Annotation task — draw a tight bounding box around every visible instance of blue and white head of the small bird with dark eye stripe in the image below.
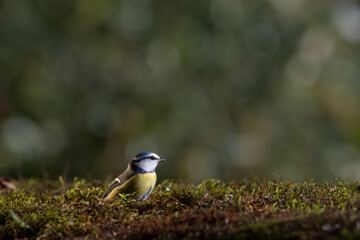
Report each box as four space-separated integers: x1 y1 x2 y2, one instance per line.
129 152 165 172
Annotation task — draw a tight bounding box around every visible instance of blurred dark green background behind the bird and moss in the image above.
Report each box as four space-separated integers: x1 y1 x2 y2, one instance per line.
0 0 360 182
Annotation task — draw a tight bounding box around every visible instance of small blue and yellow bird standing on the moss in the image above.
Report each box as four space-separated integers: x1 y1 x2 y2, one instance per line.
102 152 165 201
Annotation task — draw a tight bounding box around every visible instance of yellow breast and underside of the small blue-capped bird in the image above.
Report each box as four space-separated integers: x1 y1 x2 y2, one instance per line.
107 172 156 200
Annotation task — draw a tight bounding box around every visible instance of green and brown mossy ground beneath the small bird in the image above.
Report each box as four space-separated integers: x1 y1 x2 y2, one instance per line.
0 178 360 239
